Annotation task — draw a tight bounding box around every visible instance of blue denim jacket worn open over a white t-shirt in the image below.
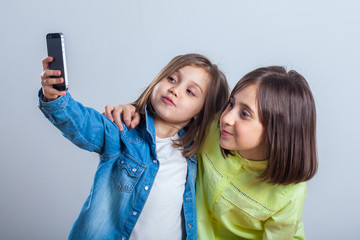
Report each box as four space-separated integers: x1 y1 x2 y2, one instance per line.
39 90 197 240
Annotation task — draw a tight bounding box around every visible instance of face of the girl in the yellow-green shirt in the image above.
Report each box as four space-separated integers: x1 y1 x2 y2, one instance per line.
220 84 266 160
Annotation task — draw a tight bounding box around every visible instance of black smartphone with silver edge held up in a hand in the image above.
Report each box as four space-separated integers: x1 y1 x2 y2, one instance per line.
46 33 69 91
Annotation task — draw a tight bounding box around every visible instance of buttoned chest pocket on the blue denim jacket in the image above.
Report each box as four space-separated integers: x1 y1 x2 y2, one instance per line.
111 155 145 192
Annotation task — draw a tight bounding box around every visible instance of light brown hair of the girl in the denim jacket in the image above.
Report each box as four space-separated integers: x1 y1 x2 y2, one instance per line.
134 53 229 157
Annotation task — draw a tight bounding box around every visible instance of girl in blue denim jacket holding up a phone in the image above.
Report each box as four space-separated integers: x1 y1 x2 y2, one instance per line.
39 54 228 240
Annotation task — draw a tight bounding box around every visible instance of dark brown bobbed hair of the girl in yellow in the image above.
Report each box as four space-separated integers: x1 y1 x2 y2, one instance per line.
222 66 318 185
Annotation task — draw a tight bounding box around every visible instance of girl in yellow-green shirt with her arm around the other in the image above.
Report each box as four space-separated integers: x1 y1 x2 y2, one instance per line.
107 66 317 240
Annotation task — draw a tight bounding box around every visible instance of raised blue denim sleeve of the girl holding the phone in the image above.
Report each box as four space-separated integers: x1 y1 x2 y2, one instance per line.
39 90 120 155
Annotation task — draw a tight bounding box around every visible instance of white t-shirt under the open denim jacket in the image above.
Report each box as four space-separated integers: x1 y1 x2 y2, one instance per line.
130 135 187 240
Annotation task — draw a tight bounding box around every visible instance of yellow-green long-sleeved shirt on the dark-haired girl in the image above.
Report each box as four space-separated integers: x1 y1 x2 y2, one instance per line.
196 119 307 240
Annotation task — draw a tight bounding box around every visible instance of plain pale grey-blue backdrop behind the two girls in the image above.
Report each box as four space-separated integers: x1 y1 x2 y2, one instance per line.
0 0 360 239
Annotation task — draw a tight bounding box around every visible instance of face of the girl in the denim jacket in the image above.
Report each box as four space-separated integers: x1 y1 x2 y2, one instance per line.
151 63 210 128
